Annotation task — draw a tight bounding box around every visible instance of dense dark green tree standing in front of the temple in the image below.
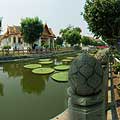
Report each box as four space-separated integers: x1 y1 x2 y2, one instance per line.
21 17 43 46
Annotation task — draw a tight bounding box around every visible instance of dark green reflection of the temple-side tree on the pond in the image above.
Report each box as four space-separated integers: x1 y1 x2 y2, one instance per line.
21 69 49 95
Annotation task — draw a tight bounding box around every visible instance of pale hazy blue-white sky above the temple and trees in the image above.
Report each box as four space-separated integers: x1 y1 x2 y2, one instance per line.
0 0 91 36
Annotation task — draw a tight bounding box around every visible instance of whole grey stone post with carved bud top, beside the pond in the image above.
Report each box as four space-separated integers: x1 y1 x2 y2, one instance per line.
68 53 105 120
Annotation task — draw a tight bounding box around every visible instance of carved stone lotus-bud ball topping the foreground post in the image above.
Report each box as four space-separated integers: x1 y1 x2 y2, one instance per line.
68 53 103 96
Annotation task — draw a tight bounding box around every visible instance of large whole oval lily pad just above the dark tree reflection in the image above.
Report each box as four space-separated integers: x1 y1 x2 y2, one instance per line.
32 68 54 74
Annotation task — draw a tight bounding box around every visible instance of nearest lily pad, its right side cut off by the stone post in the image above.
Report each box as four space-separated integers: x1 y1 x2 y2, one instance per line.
51 72 68 82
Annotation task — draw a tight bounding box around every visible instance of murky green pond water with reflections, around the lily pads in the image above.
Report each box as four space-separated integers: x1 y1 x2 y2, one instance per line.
0 55 75 120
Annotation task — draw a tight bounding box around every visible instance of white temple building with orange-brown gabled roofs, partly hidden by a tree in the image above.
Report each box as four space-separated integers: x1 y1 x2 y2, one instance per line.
0 24 55 50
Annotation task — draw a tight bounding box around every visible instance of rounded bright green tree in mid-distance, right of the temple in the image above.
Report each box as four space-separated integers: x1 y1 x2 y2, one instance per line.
60 26 81 46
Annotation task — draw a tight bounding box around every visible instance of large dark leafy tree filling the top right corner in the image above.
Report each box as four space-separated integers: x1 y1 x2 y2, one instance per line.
83 0 120 49
